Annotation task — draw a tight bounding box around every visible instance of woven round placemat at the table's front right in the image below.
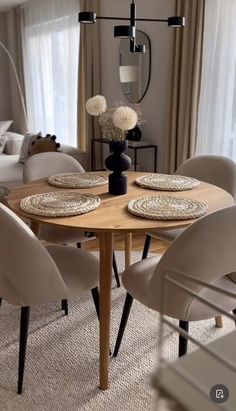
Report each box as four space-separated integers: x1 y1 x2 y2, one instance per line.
128 195 208 220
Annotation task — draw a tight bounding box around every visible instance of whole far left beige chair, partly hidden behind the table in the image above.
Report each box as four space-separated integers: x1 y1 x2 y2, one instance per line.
23 152 120 292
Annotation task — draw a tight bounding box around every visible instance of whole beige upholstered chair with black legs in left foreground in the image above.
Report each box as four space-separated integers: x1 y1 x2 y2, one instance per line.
0 204 99 394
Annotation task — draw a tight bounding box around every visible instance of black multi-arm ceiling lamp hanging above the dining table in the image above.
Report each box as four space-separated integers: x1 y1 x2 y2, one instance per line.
79 0 185 53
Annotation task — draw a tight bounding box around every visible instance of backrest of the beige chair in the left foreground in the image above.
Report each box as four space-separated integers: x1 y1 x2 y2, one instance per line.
0 204 66 306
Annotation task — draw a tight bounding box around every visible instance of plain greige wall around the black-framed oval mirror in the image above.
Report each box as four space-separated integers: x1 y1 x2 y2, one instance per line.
101 0 175 171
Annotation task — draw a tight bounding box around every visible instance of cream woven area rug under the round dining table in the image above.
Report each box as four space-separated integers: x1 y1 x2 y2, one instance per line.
0 252 234 411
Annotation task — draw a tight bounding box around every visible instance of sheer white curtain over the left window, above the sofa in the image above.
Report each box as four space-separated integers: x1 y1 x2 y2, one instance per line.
22 0 80 146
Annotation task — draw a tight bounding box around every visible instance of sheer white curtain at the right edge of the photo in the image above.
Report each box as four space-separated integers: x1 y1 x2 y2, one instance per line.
196 0 236 160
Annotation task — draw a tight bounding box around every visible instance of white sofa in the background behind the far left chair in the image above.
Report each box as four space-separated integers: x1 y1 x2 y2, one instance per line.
0 131 88 188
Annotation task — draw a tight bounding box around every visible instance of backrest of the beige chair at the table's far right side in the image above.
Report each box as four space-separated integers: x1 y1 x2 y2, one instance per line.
175 155 236 198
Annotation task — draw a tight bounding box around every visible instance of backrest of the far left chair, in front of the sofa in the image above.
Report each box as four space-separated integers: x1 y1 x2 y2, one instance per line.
23 152 84 183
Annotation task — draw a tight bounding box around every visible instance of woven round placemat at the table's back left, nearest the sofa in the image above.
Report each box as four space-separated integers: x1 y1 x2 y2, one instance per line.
48 173 108 188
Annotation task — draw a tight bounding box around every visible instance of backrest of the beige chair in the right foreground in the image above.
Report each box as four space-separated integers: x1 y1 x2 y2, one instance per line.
147 206 236 319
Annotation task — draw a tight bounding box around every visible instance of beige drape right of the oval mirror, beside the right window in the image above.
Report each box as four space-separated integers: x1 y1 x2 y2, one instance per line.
165 0 205 173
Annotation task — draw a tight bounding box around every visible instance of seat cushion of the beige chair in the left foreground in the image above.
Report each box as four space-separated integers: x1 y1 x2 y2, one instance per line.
46 245 99 298
